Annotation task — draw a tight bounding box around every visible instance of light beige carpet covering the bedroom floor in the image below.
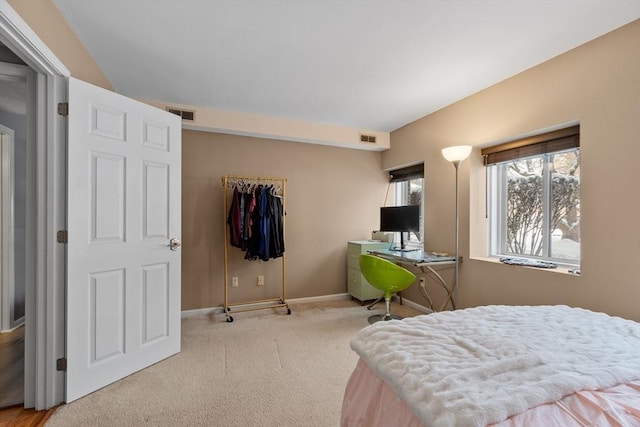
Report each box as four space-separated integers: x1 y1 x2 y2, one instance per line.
46 300 420 427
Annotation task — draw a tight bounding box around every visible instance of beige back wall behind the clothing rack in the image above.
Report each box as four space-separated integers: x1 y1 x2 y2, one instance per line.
182 131 388 310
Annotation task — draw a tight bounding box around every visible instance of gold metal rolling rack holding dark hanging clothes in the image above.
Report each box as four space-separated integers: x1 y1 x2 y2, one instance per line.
221 175 291 322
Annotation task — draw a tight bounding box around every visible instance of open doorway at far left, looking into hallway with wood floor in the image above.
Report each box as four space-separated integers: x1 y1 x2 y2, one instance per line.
0 49 33 408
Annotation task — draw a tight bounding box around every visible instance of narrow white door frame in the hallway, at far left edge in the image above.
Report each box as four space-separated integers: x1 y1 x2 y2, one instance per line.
0 124 15 331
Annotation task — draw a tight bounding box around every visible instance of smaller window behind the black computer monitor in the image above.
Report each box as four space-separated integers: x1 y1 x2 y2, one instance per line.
389 163 424 249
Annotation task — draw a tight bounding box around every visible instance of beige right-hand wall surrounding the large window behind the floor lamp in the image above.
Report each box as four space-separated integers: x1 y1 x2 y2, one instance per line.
382 21 640 320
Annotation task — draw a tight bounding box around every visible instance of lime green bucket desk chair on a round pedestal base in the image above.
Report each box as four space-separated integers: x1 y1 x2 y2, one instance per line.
358 254 416 323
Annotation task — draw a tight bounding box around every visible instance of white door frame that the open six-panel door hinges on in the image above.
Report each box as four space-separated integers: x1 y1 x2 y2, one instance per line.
0 0 71 410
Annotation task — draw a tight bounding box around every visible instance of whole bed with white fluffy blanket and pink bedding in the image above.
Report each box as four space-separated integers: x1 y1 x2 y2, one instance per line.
341 306 640 427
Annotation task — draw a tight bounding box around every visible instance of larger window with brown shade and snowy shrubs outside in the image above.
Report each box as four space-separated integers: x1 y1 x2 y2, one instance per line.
482 126 580 266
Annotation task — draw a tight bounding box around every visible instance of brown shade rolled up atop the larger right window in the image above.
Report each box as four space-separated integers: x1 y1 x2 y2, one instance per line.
481 125 580 165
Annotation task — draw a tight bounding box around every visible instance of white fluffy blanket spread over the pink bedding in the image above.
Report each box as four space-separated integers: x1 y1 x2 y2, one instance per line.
351 306 640 427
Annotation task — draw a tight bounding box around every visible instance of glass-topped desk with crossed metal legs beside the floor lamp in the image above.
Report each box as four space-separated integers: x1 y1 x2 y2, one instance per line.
369 249 456 311
